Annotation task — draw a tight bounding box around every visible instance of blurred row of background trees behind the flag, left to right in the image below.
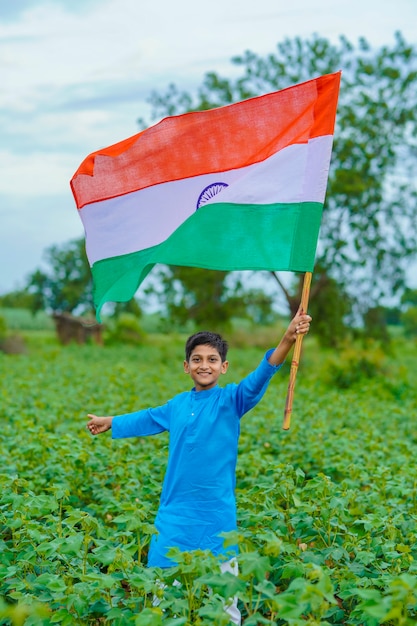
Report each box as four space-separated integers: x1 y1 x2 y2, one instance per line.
1 33 417 345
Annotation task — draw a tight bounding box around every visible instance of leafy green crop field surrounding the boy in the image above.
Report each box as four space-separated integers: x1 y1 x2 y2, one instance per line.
0 336 417 626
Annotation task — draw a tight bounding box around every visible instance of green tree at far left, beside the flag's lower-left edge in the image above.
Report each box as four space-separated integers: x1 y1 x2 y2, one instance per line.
27 239 94 313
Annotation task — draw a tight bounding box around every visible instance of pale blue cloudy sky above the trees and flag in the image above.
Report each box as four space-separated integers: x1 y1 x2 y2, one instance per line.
0 0 417 294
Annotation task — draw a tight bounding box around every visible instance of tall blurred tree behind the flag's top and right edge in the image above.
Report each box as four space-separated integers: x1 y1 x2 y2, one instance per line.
141 33 417 336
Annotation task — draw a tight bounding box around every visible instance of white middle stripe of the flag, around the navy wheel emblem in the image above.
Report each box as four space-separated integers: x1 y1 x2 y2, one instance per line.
80 135 333 265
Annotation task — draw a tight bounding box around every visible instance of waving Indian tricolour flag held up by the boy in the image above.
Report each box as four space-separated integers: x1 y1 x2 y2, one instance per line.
71 72 340 317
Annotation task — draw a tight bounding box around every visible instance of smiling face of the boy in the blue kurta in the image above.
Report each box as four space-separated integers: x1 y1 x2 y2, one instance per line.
184 345 229 391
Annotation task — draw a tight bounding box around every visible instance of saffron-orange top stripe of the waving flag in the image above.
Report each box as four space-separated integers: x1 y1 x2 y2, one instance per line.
71 72 340 208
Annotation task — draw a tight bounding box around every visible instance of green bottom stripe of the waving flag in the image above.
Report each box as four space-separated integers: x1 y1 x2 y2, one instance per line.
92 202 323 315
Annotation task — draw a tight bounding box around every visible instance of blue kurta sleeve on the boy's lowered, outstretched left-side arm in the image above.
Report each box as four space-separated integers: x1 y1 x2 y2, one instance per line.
112 402 170 439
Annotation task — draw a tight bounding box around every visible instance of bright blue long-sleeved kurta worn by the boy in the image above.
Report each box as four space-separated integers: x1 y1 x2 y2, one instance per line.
112 350 281 567
